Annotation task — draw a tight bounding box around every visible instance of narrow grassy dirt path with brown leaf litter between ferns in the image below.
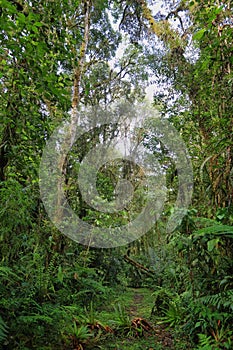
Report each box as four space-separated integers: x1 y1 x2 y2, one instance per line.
101 288 191 350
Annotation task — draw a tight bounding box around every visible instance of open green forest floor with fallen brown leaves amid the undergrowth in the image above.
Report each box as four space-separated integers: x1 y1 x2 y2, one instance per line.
96 288 189 350
